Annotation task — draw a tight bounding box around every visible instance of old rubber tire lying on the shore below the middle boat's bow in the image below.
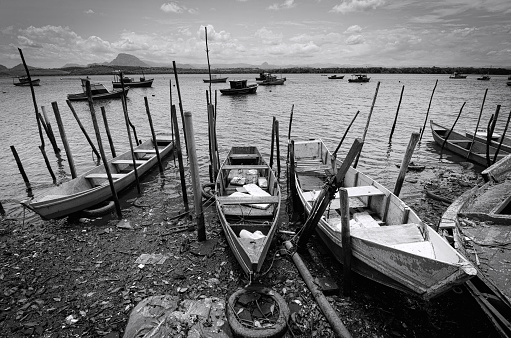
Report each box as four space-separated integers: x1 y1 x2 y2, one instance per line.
226 286 289 338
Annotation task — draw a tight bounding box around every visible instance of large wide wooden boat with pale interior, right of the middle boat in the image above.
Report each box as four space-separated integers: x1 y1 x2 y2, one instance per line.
290 140 476 299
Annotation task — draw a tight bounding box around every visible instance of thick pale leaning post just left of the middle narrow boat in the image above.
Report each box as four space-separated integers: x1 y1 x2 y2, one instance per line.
184 111 206 242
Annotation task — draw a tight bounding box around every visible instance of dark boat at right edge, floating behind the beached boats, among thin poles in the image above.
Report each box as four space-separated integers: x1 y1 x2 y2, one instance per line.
430 120 509 167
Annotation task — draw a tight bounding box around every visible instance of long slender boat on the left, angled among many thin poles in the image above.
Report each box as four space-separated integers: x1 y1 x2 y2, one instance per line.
21 135 174 219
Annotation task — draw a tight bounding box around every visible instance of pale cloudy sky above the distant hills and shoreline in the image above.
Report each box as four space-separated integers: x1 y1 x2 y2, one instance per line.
0 0 511 68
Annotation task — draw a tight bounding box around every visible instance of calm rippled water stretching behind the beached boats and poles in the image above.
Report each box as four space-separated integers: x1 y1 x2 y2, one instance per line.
0 74 511 217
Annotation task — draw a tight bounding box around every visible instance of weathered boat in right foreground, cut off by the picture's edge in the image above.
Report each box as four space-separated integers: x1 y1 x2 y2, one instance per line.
439 155 511 337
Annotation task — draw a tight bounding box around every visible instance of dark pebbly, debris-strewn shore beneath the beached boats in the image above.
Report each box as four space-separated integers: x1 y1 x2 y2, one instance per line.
0 162 496 338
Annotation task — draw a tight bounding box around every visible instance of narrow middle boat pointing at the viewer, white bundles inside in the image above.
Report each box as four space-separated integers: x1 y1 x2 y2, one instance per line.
215 146 281 275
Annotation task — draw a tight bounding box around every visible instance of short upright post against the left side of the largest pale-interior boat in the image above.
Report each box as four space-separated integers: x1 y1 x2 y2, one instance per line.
339 188 351 296
